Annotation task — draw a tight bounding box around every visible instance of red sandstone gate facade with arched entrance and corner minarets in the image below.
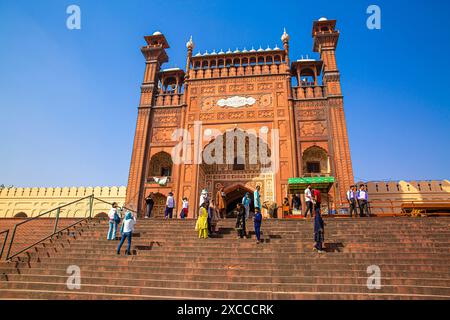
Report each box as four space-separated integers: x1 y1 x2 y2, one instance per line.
126 18 354 217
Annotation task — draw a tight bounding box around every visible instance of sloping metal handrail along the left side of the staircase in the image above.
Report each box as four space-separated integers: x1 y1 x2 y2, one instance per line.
6 194 96 260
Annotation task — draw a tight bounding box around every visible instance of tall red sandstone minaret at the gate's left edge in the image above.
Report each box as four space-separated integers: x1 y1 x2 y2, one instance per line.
126 31 169 213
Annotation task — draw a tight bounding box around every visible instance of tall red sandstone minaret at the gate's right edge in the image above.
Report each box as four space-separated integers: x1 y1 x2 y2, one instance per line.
312 18 354 203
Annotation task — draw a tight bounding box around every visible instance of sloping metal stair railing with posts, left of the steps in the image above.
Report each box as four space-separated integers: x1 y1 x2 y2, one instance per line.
0 194 95 260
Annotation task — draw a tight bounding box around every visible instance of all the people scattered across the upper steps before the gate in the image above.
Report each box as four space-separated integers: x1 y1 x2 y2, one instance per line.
118 184 369 255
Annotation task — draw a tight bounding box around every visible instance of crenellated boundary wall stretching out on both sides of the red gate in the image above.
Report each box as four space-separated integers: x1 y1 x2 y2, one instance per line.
0 180 450 218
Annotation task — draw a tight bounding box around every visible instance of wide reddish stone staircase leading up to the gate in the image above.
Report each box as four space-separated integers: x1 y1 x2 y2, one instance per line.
0 218 450 300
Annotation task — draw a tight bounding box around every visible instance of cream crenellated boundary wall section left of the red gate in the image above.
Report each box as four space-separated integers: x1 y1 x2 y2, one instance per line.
0 187 127 218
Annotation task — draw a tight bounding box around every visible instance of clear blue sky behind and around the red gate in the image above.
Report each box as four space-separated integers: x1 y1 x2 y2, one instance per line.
0 0 450 186
